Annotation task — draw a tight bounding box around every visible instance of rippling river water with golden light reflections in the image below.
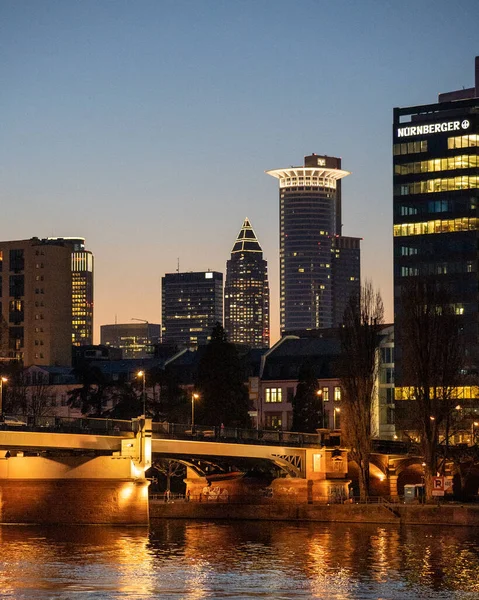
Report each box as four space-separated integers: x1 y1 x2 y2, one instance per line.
0 520 479 600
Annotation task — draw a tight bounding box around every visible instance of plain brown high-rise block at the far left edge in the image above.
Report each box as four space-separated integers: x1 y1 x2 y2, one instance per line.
0 238 72 367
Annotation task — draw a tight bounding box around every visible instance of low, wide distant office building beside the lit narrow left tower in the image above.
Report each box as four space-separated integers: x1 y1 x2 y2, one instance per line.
100 321 160 358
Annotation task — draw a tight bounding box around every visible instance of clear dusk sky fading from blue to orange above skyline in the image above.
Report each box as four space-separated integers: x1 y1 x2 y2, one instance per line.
0 0 479 342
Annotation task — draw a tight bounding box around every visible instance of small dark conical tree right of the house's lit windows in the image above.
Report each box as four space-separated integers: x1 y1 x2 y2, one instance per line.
292 364 324 433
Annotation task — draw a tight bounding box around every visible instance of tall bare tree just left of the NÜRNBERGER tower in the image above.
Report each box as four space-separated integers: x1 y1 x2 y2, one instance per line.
340 281 384 499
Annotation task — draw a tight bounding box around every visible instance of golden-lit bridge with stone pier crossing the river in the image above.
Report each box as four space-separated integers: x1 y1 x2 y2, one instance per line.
0 417 420 524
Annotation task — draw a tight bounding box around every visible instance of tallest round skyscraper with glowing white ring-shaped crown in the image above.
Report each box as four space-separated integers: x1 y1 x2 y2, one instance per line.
267 154 360 332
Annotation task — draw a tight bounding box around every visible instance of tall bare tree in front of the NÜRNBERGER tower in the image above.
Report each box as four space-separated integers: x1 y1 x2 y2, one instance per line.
398 280 464 499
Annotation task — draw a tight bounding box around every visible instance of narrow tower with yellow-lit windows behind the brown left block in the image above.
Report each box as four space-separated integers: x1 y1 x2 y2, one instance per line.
48 237 93 346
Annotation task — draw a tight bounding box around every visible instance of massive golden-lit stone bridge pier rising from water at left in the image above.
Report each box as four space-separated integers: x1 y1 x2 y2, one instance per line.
0 419 151 525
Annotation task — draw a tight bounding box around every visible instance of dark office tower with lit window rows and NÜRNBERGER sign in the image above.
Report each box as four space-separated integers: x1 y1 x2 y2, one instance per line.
393 58 479 385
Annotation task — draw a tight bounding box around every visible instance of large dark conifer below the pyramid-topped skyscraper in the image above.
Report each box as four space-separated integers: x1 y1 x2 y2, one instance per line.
195 323 250 427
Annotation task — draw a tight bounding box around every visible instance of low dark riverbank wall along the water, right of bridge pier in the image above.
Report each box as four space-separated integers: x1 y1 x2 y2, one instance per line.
150 500 479 527
